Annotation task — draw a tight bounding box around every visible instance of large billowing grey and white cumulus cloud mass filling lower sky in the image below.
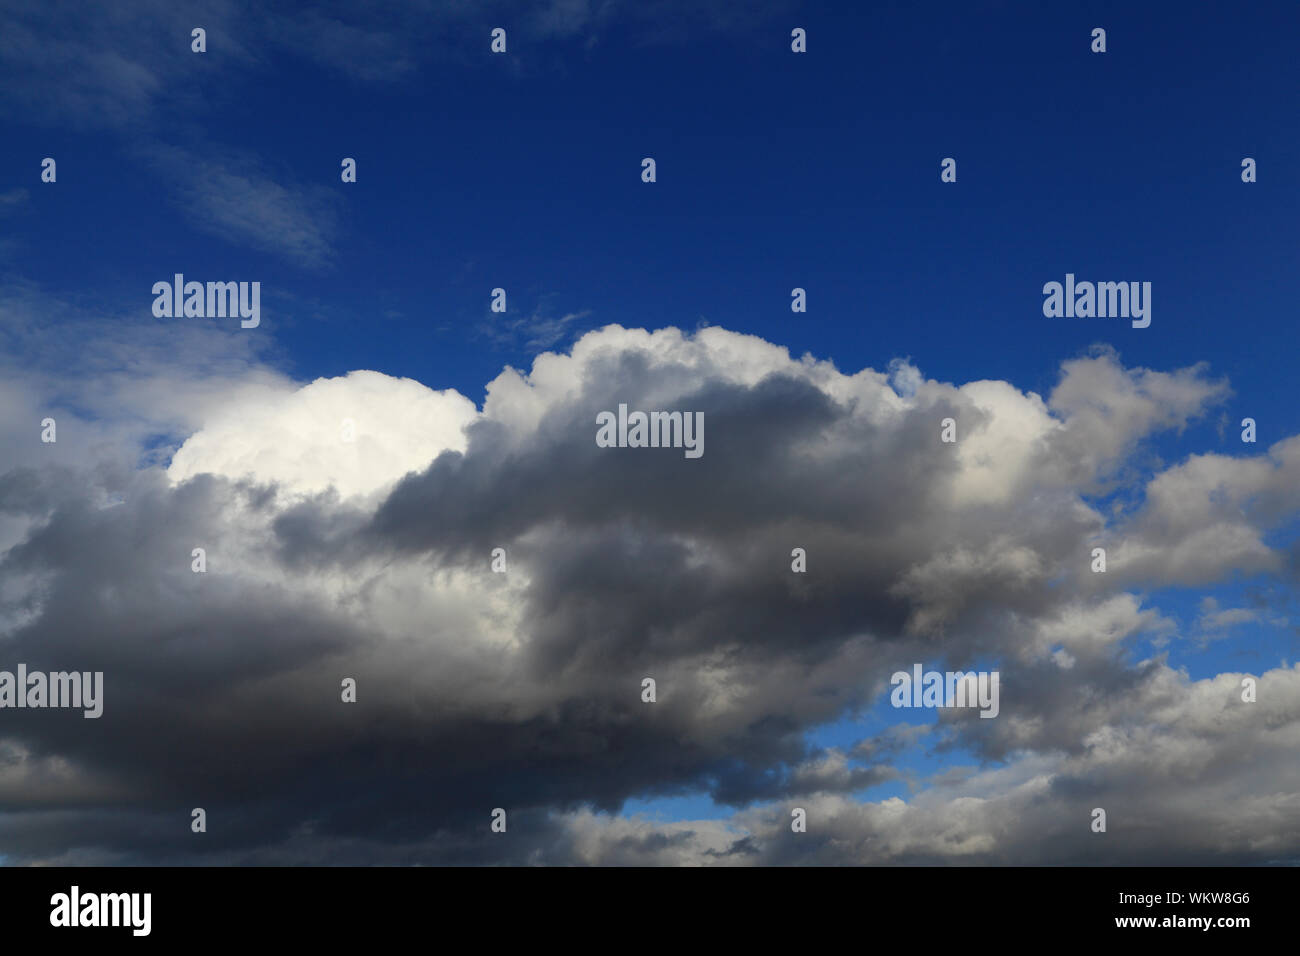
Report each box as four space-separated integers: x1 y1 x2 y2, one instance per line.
0 317 1300 864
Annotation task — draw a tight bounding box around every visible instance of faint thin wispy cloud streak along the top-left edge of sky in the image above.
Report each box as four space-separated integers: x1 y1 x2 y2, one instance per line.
0 0 789 131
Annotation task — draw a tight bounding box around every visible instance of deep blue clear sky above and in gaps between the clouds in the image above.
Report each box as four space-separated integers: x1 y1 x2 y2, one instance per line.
0 3 1300 868
